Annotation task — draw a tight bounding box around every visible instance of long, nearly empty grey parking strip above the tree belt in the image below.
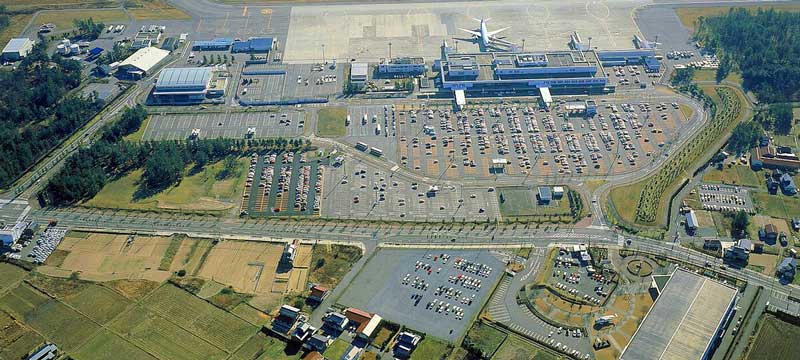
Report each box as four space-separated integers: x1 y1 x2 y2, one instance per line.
143 110 305 140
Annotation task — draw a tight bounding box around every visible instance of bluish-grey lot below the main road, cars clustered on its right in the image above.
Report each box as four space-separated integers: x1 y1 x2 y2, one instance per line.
339 249 504 341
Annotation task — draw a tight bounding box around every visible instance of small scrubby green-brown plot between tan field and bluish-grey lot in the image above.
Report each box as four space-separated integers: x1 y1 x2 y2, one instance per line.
308 244 361 289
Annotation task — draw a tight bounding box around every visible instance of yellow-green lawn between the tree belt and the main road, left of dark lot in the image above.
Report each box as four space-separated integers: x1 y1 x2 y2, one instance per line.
83 157 249 212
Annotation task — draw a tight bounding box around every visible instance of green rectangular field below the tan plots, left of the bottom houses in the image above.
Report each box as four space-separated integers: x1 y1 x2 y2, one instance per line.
140 284 256 352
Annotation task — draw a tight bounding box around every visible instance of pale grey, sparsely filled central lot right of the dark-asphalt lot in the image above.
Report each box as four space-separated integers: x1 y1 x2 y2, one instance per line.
322 158 499 221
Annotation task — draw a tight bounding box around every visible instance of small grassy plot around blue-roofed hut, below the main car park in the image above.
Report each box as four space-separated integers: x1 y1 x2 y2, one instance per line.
497 187 570 217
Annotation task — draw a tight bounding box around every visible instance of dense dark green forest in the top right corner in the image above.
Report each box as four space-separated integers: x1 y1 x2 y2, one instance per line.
695 8 800 102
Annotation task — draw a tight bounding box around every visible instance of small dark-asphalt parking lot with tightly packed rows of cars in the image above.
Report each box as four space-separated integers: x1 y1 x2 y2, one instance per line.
241 152 327 216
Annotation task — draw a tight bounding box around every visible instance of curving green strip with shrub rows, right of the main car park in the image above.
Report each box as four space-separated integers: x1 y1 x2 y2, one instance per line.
608 86 745 231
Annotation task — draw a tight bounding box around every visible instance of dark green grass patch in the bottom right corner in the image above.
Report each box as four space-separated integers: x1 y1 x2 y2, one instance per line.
747 314 800 360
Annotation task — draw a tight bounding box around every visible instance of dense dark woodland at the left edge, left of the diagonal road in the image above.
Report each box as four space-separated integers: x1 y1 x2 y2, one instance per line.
0 42 104 187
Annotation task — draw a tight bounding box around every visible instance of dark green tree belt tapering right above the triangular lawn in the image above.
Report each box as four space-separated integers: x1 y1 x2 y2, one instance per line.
39 105 311 206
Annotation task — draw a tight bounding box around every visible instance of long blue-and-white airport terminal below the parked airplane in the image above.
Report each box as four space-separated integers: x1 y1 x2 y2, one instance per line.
434 44 613 105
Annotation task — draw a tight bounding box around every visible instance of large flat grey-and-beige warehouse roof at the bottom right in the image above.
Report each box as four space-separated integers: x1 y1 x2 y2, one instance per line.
620 269 737 360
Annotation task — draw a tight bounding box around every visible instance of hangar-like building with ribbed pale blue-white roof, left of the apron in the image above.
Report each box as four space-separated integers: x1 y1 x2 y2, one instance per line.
152 67 227 104
